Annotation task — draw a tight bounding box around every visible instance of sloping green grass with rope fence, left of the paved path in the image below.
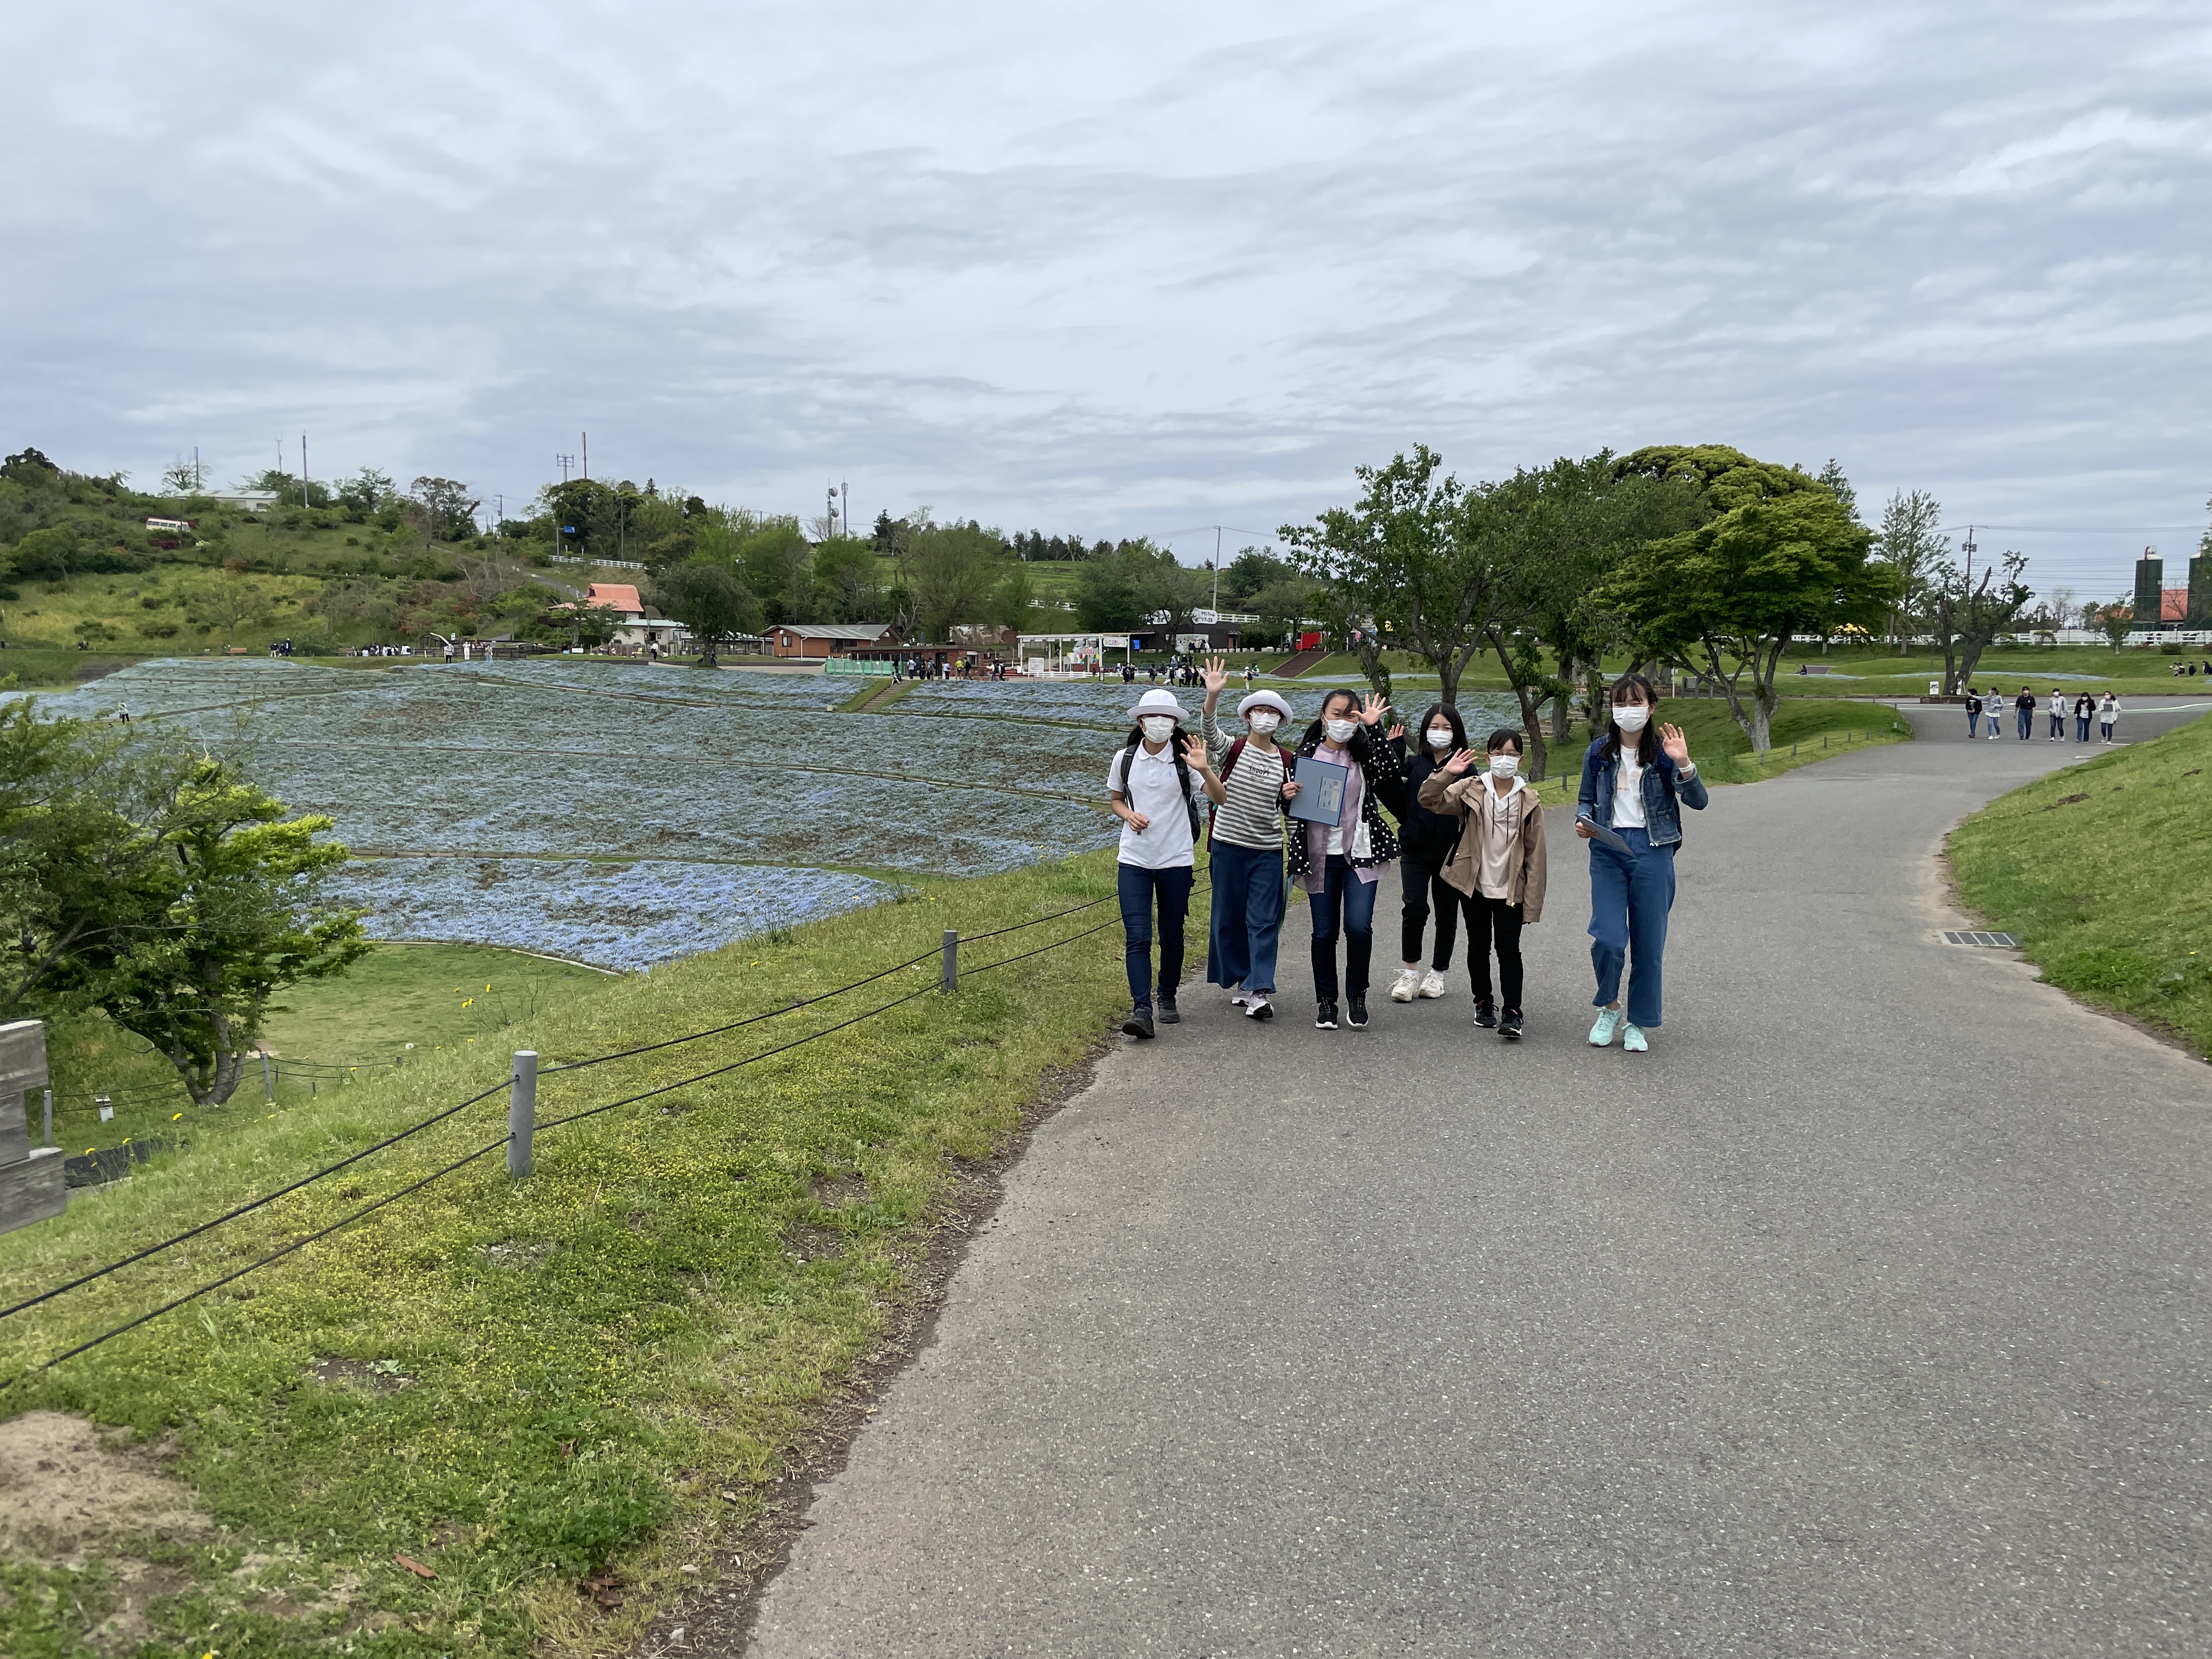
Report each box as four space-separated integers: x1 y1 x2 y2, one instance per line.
0 851 1132 1659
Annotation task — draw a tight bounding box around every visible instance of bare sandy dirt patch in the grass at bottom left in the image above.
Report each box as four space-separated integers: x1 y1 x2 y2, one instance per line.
0 1411 210 1553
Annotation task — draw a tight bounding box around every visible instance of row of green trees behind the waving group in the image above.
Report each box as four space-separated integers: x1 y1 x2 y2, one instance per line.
1283 444 2033 768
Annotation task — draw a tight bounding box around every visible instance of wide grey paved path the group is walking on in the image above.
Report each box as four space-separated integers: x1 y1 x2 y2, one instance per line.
752 703 2212 1659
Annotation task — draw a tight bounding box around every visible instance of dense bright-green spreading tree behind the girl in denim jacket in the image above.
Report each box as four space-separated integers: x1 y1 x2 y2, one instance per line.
1595 444 1903 754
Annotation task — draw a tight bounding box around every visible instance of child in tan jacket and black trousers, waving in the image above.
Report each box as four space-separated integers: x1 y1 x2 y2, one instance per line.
1420 725 1544 1037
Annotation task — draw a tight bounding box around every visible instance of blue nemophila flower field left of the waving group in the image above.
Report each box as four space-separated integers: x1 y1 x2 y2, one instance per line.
24 659 1113 967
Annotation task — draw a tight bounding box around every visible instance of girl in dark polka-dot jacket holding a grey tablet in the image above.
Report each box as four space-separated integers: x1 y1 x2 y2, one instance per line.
1290 690 1400 1031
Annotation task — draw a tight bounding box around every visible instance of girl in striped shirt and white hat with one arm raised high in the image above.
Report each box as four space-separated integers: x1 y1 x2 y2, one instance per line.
1199 657 1303 1020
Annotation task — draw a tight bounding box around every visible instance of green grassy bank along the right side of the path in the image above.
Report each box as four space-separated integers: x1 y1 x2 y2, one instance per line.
1951 719 2212 1057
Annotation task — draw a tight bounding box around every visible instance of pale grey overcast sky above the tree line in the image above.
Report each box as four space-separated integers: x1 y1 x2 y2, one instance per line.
0 0 2212 597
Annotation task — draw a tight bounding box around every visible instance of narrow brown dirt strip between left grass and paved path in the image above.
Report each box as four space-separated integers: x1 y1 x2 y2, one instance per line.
630 1026 1119 1659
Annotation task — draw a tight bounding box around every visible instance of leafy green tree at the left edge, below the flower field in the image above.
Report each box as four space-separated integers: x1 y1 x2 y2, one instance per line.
0 710 367 1106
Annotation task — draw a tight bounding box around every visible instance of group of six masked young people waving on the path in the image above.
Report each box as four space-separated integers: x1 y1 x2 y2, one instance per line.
1106 659 1708 1053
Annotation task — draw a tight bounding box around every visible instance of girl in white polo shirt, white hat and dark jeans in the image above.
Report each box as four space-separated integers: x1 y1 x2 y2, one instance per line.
1106 690 1226 1037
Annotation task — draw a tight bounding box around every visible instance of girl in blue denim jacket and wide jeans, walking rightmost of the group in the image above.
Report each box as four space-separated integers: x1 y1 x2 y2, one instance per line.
1575 675 1707 1053
